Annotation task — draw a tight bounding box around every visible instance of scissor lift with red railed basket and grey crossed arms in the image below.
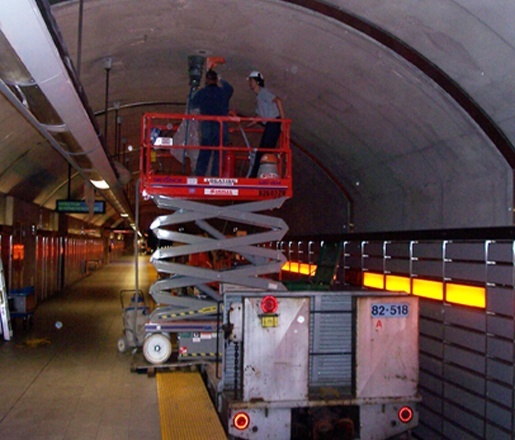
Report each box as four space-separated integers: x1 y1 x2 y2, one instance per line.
140 113 292 364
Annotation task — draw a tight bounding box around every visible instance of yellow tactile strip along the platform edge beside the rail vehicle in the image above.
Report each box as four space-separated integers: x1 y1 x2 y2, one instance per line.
156 371 227 440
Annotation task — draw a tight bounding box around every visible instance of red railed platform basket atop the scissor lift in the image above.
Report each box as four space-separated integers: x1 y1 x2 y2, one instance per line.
140 113 292 200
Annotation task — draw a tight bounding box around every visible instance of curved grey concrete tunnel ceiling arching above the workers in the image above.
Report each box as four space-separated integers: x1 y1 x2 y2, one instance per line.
0 0 515 234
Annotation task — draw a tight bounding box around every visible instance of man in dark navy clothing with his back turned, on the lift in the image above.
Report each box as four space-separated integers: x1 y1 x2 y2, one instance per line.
190 70 234 176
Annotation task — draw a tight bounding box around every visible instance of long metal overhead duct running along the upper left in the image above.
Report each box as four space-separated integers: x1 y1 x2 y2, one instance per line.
0 0 134 223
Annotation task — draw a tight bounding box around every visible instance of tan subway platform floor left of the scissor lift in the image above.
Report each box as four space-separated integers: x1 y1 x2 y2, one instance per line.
0 256 161 440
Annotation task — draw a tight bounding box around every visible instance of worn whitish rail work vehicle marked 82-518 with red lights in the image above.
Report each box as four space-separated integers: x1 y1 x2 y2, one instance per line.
213 290 420 440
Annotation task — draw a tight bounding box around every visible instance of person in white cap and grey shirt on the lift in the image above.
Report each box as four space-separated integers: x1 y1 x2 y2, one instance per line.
247 71 284 177
